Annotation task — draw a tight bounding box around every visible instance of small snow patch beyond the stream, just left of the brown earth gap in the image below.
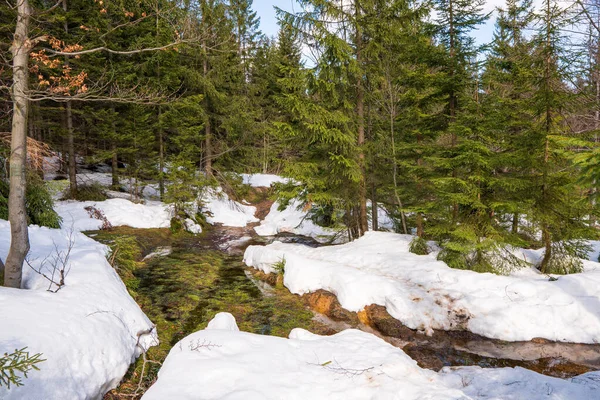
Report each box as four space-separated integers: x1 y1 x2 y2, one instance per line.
200 188 258 227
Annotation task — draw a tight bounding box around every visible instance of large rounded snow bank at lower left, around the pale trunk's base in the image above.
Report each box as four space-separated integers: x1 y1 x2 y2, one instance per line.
0 220 157 400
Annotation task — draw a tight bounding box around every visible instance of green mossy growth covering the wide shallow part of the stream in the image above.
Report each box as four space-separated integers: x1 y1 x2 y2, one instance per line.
93 227 322 398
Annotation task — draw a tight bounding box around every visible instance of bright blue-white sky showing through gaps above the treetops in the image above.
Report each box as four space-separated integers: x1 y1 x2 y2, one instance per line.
253 0 504 44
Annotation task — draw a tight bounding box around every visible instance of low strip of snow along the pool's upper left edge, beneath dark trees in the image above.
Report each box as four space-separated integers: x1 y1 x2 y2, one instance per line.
54 199 171 231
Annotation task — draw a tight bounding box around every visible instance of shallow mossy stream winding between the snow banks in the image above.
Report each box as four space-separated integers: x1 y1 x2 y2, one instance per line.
87 226 600 399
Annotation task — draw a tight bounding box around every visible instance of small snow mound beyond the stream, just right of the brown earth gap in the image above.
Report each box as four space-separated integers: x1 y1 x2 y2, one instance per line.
254 200 338 242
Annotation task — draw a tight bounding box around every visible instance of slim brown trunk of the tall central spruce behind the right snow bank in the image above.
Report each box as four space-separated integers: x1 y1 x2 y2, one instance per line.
354 0 369 236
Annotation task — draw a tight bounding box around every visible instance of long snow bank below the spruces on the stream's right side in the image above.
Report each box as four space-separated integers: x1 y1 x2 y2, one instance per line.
244 232 600 343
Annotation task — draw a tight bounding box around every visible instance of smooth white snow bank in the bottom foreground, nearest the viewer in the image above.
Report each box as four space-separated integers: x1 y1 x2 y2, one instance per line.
143 313 600 400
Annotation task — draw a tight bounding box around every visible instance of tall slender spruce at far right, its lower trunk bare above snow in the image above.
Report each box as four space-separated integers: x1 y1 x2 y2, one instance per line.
523 0 590 273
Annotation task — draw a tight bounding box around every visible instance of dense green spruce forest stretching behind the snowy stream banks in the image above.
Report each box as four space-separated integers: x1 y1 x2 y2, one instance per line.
0 0 600 273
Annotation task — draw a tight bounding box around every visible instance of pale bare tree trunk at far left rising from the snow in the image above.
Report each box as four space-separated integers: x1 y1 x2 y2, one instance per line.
4 0 31 288
